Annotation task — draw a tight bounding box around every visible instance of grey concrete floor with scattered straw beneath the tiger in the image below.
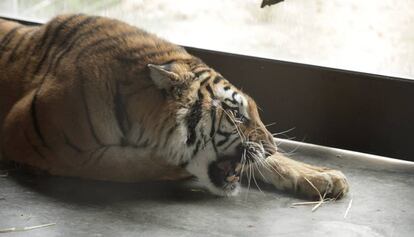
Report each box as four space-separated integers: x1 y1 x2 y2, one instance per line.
0 143 414 237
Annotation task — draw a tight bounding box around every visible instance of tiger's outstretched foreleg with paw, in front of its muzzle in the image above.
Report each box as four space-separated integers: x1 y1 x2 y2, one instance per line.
249 153 349 199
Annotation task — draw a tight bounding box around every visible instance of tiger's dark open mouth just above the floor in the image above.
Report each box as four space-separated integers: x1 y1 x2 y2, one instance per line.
208 157 242 191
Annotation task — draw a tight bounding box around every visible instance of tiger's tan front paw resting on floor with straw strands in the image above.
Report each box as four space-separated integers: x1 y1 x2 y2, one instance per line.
296 168 349 200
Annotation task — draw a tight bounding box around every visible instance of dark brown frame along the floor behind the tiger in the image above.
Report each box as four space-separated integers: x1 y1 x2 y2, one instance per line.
3 18 414 161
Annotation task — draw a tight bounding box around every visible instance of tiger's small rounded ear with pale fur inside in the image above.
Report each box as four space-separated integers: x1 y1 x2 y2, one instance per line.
148 63 182 90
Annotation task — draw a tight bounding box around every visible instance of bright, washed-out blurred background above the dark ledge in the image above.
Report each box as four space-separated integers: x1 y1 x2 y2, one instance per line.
0 0 414 79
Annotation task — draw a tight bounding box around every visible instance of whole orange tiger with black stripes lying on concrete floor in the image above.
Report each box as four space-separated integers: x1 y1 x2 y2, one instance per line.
0 14 349 198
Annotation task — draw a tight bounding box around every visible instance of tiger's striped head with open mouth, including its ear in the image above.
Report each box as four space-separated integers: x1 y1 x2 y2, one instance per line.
148 58 276 196
